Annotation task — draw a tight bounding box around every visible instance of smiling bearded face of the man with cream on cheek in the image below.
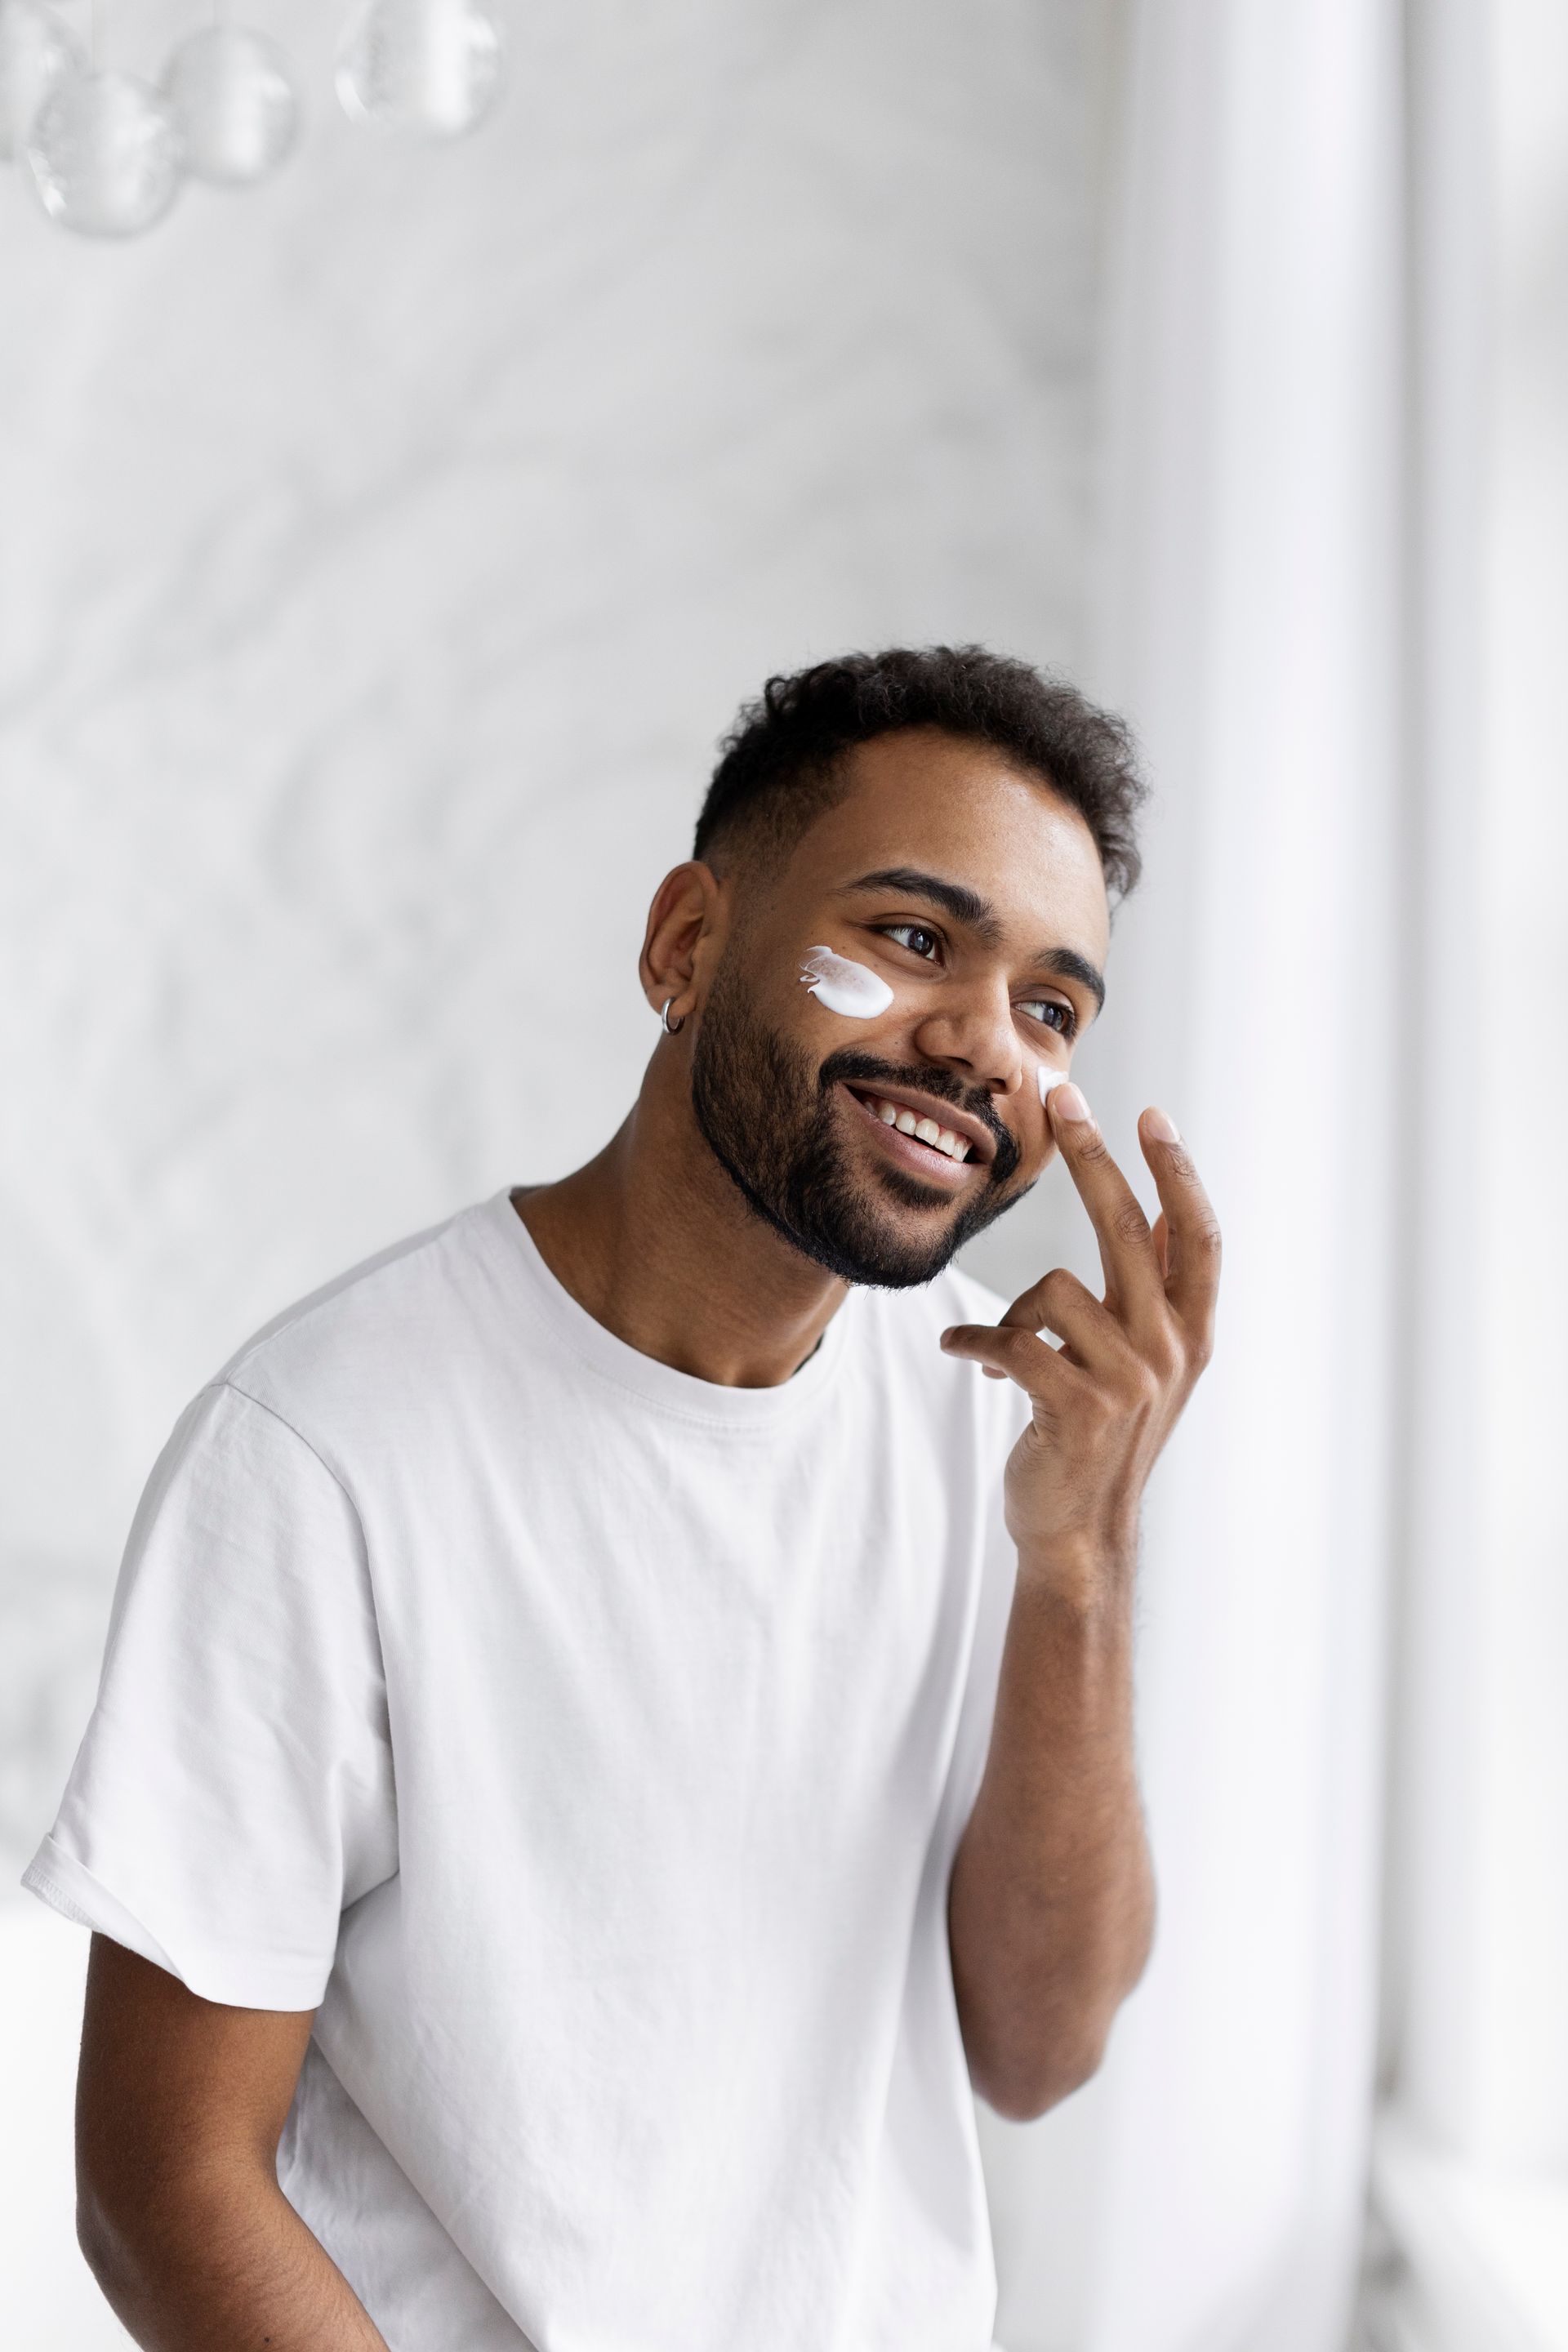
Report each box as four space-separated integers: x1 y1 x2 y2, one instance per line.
691 729 1110 1289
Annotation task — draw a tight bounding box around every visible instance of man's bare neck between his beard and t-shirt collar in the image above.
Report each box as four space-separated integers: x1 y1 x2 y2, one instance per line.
514 1040 849 1388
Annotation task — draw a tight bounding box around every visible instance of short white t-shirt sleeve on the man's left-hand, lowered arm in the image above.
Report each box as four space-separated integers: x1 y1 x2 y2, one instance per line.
24 1383 397 2009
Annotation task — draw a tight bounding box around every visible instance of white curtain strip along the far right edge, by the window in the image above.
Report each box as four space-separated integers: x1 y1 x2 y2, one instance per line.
1368 0 1568 2352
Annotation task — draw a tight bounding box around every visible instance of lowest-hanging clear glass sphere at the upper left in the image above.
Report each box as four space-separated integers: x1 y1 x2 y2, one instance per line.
29 73 181 238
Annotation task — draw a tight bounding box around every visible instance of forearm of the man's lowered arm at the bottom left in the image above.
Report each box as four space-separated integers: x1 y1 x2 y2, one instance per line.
80 2166 385 2352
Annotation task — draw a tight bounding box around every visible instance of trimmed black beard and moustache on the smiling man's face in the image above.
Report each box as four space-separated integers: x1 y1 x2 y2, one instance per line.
691 955 1030 1291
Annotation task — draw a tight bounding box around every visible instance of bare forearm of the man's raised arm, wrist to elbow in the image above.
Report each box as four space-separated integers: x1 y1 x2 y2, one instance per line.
947 1545 1154 2117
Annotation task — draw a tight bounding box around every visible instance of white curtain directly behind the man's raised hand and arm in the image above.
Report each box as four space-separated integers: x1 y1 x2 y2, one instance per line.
987 0 1404 2352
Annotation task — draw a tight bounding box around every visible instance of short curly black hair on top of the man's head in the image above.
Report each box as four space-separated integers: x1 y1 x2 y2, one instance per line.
691 644 1147 898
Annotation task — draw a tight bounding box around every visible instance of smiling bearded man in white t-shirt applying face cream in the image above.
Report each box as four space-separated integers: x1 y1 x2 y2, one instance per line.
29 649 1218 2352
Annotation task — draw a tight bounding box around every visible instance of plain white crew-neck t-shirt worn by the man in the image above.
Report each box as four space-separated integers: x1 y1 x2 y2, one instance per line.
26 1192 1025 2352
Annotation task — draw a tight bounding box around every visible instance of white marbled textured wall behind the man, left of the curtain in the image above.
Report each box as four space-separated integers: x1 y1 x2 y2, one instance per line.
0 0 1094 2352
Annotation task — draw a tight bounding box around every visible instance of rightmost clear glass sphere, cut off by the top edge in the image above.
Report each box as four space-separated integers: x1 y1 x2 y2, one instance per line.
336 0 501 139
